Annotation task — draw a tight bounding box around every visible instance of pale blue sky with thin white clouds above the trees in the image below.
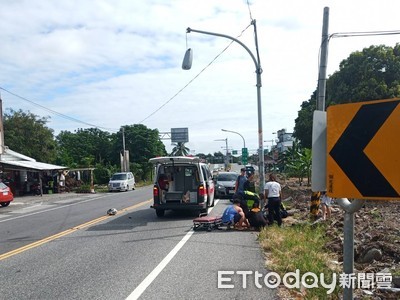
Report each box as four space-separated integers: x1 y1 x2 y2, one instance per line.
0 0 400 153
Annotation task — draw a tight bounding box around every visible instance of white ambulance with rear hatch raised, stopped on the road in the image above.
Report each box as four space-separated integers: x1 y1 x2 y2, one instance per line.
150 156 214 217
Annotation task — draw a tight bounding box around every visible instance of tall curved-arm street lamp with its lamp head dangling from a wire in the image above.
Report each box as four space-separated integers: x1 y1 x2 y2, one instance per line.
182 20 265 193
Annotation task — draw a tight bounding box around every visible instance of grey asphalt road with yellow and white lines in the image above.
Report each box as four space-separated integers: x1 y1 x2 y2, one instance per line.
0 187 276 299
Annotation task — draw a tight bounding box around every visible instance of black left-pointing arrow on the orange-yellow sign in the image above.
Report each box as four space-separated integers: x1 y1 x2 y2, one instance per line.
329 100 400 197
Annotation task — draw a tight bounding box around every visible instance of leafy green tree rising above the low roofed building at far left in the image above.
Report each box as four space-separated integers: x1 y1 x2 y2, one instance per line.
3 109 57 163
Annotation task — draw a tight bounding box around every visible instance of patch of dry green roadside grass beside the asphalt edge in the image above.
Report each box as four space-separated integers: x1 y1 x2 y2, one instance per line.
259 224 340 299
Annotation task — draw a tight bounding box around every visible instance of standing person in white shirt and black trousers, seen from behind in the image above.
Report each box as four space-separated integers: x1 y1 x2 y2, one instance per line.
264 173 282 226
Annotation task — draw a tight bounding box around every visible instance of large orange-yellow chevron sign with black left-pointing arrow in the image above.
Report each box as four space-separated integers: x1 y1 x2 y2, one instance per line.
327 98 400 200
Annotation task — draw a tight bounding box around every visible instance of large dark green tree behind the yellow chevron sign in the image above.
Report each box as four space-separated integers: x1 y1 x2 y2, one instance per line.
293 44 400 148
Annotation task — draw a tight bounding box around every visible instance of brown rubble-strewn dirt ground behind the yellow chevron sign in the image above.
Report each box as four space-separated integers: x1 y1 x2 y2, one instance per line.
282 184 400 299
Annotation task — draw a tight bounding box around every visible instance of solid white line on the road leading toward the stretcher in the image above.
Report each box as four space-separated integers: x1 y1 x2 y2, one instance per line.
126 199 219 300
